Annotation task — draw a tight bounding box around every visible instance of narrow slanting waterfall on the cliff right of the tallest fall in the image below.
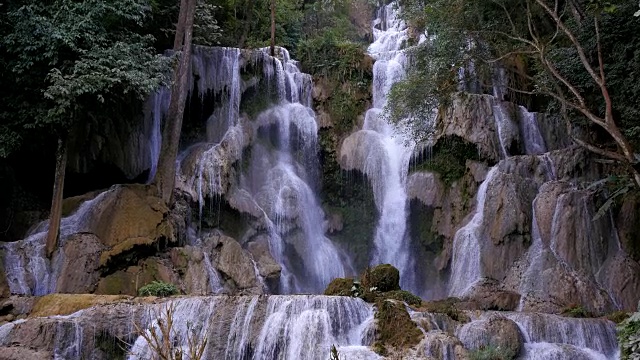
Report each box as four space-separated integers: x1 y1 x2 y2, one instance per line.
449 166 498 296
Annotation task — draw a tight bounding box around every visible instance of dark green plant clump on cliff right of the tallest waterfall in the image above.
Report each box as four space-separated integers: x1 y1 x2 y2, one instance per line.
413 135 480 186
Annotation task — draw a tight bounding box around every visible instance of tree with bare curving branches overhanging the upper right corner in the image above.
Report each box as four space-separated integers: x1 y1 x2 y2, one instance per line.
391 0 640 186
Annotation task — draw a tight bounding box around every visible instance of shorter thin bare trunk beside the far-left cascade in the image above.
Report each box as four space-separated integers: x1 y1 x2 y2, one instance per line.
45 137 67 257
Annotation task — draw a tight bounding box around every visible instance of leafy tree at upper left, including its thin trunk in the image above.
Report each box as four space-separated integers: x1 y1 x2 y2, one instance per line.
1 0 168 256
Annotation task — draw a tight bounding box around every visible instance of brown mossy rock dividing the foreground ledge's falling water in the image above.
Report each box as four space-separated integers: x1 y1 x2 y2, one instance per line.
374 300 422 355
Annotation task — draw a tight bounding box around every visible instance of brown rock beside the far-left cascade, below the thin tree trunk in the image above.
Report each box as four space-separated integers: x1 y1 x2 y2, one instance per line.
56 233 105 294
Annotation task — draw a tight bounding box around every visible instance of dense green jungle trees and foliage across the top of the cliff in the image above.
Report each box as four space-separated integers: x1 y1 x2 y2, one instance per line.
0 0 640 239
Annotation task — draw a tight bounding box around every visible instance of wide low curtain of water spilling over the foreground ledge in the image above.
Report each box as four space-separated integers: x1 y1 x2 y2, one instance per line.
129 296 379 360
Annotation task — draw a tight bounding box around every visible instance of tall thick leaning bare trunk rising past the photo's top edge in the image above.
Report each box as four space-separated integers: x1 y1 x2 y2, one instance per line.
154 0 196 204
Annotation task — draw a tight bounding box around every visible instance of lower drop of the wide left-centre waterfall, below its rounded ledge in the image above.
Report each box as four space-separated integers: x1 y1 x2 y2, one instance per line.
248 103 352 293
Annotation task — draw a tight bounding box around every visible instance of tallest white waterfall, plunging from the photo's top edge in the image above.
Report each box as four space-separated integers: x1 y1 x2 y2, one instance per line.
341 2 421 293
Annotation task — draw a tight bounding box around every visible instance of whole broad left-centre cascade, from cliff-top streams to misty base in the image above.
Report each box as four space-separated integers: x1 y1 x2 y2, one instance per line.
179 48 352 293
